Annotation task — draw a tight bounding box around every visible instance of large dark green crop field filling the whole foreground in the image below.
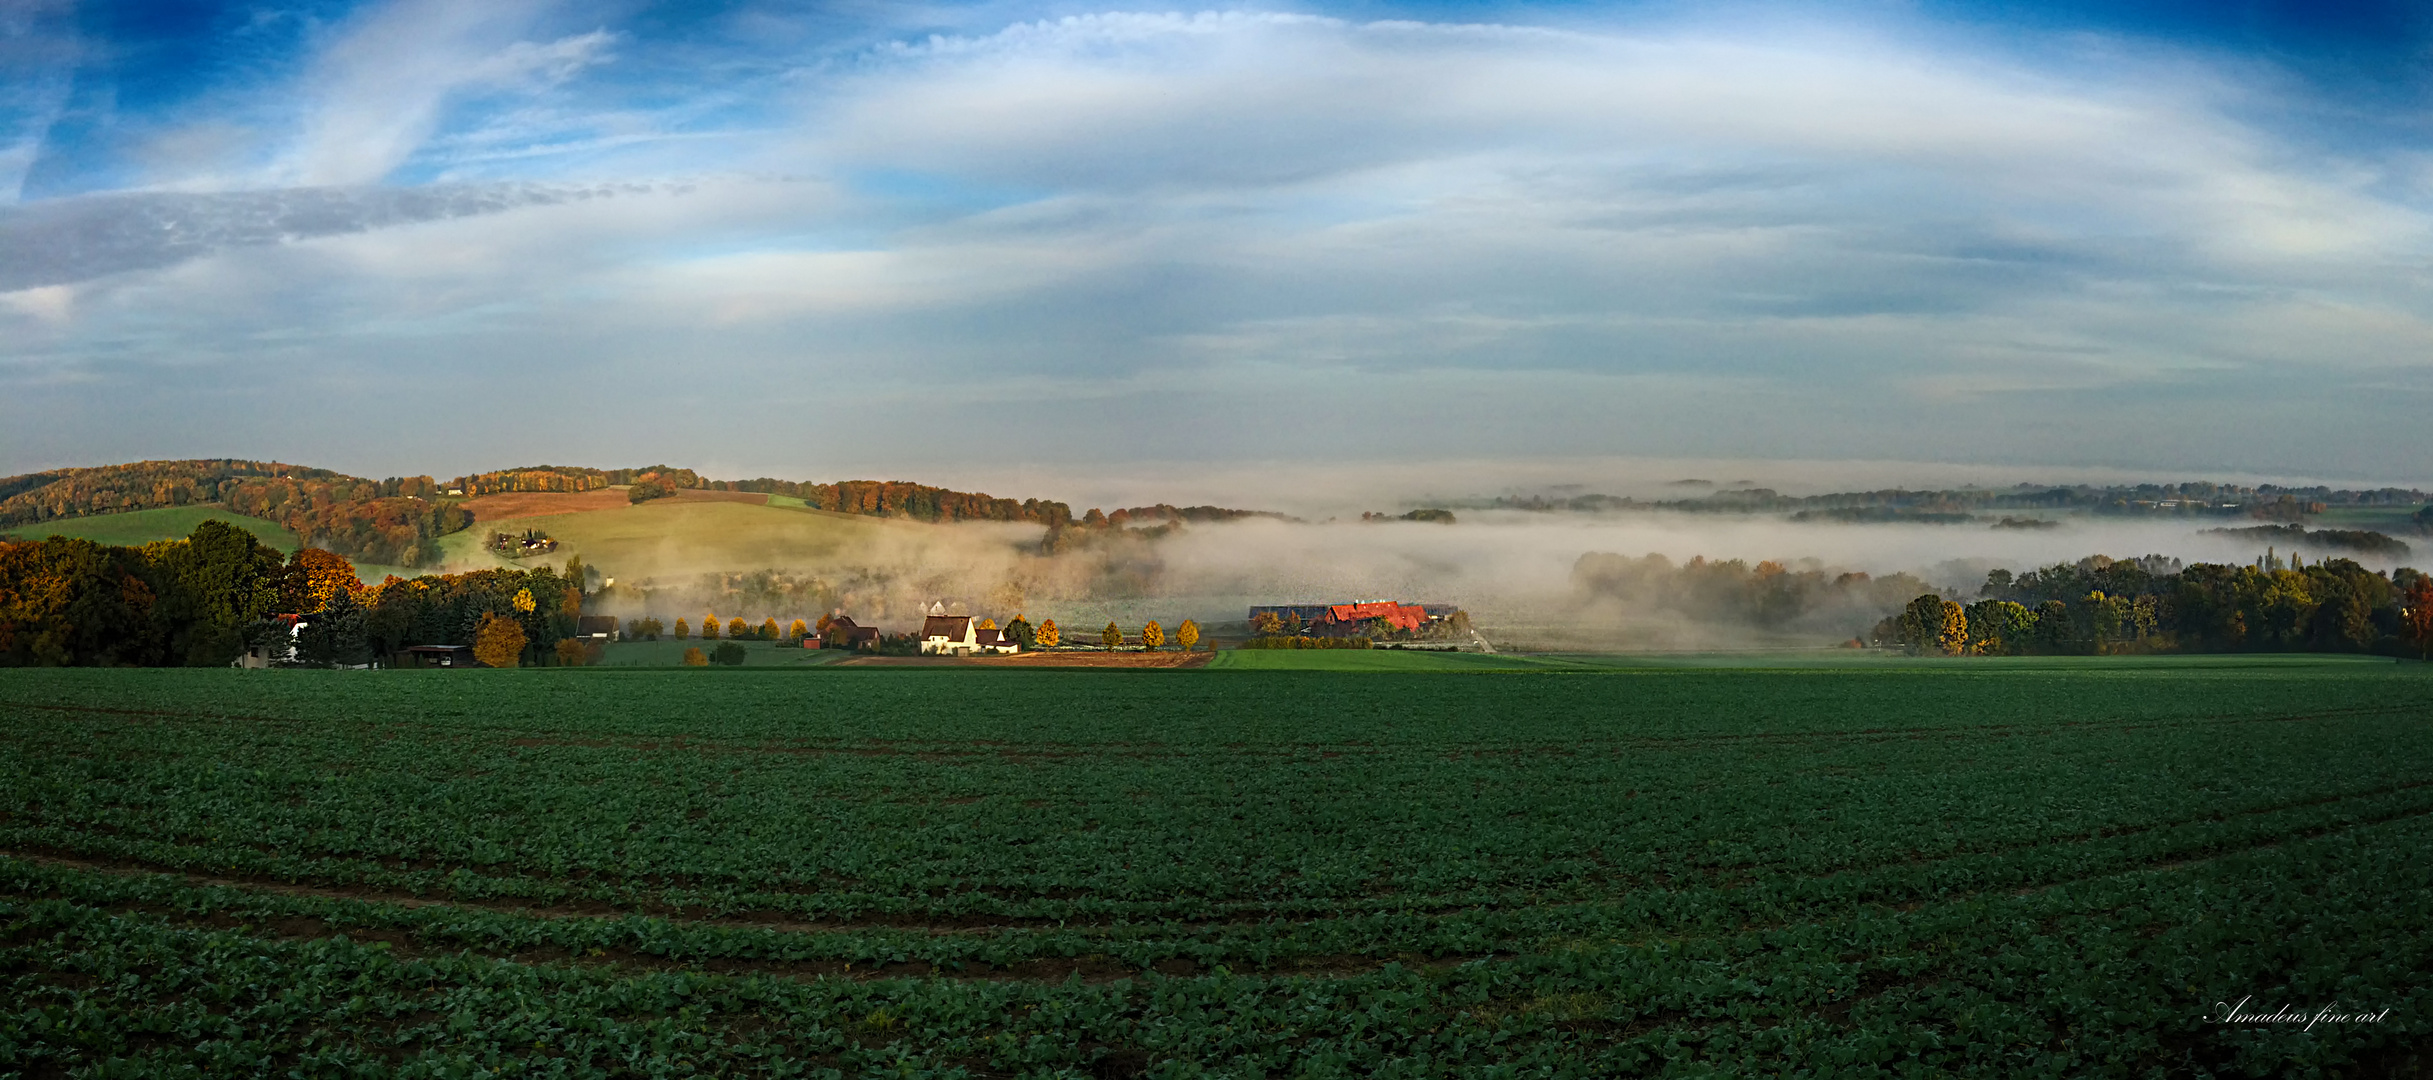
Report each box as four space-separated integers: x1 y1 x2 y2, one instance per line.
0 657 2433 1078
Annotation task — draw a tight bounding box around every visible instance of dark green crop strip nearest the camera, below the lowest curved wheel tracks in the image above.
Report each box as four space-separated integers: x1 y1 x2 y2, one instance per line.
0 817 2433 1075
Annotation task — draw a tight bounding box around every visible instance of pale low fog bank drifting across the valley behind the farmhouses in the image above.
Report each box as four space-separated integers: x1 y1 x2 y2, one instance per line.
574 511 2392 649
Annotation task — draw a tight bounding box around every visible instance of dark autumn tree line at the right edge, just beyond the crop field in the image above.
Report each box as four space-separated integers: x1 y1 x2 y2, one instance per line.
1871 555 2433 659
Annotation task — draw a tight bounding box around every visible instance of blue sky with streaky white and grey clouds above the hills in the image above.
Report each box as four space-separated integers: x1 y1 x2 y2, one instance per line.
0 0 2433 498
